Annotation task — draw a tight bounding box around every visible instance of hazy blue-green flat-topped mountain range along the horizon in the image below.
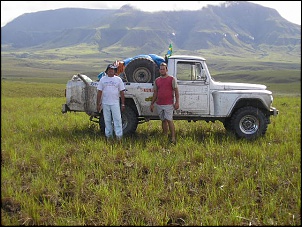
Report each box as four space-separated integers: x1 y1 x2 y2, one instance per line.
1 1 301 57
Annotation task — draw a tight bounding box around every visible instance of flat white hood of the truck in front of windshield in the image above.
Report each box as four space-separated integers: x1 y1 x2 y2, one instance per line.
213 81 266 90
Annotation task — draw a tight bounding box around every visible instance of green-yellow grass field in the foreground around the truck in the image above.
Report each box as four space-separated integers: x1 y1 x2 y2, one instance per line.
1 80 301 226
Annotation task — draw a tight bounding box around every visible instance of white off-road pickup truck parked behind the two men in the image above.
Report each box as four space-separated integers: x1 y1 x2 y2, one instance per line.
62 55 279 140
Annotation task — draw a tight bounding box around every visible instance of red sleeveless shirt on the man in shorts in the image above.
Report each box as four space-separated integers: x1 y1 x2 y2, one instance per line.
155 76 174 105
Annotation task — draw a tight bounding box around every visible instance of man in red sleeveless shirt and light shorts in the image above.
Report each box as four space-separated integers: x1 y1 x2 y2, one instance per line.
150 62 179 144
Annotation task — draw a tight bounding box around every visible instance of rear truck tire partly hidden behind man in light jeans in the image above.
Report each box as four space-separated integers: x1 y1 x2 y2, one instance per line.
99 105 138 135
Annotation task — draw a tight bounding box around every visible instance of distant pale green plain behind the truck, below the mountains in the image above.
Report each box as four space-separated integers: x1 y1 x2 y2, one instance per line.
1 44 301 90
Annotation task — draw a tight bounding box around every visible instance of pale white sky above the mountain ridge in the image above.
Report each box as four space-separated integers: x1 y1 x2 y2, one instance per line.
1 1 301 27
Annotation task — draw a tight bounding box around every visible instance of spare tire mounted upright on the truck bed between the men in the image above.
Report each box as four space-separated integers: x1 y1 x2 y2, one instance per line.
125 58 159 83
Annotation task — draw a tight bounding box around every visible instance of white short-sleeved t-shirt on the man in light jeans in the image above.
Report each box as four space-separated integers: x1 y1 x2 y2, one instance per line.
97 75 125 105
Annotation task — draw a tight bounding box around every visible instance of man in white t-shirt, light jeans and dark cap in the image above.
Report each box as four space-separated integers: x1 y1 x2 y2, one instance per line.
96 64 125 140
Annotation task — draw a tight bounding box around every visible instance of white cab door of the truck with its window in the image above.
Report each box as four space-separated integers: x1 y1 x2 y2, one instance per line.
174 61 210 116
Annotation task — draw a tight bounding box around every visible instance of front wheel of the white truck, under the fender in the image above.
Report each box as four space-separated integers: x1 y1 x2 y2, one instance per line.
231 106 269 140
